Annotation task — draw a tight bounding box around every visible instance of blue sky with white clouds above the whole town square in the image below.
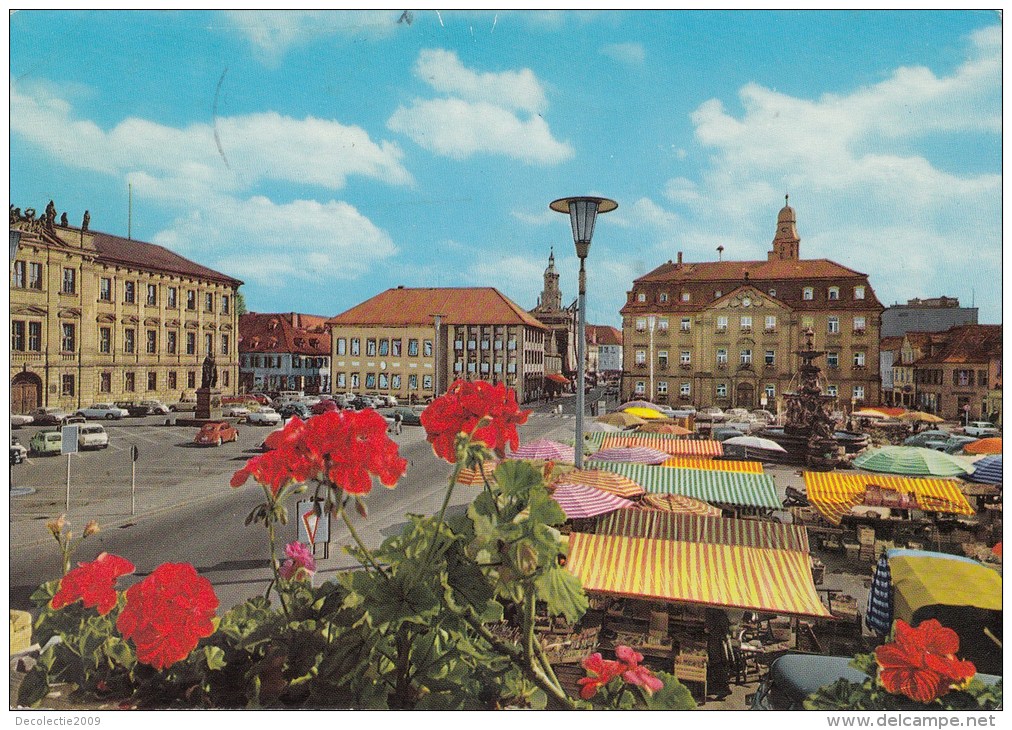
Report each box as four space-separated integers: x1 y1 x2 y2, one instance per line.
10 10 1001 325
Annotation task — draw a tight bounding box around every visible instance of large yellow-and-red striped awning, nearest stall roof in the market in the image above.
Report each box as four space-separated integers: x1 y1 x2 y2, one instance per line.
566 510 829 617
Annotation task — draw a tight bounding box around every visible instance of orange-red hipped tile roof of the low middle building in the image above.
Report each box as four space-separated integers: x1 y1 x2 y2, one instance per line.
328 287 547 329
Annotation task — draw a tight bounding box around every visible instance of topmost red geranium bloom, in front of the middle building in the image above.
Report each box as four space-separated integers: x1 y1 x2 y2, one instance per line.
422 380 530 464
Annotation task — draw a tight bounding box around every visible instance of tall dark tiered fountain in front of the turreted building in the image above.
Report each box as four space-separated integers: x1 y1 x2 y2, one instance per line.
760 329 840 471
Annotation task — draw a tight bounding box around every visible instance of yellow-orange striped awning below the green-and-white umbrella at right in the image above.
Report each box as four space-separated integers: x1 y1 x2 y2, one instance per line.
805 472 974 524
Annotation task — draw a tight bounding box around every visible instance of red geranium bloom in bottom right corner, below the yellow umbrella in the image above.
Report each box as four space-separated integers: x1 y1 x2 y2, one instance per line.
875 619 977 704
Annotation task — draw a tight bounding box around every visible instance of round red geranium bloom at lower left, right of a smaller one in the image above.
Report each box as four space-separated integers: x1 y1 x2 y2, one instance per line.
116 563 218 669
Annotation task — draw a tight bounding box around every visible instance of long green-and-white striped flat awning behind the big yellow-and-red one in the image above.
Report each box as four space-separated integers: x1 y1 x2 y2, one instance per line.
594 462 780 509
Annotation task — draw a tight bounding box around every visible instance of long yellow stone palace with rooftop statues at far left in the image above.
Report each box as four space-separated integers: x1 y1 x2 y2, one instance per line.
10 200 242 413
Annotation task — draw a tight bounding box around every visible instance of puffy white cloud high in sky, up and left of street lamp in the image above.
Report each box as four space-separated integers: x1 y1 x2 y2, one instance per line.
387 50 574 165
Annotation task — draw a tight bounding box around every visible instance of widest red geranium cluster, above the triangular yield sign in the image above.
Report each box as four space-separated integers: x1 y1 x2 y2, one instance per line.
232 409 408 494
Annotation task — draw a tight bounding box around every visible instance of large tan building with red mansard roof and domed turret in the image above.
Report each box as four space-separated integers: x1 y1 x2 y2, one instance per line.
621 199 883 411
